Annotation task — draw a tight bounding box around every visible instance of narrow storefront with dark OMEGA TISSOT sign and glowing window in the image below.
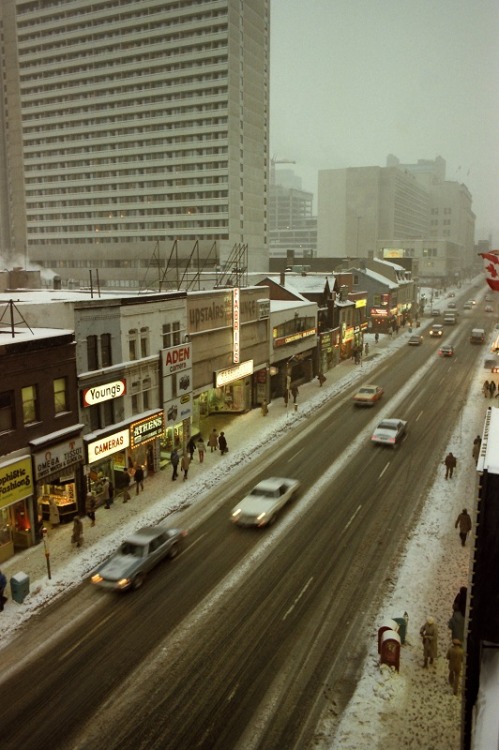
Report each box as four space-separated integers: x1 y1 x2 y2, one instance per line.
30 425 84 523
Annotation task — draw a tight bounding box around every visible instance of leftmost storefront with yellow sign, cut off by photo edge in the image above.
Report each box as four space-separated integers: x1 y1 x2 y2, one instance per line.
0 456 35 563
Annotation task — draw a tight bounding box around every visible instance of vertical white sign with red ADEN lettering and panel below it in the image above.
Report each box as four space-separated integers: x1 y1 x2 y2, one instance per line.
165 343 192 424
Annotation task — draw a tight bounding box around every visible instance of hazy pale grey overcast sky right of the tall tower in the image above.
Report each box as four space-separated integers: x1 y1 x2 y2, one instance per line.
270 0 499 247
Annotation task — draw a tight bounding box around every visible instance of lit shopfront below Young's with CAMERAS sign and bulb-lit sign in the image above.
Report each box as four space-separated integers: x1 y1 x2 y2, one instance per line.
84 411 165 506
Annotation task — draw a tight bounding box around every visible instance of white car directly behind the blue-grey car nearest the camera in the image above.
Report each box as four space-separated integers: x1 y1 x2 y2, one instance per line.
230 477 300 527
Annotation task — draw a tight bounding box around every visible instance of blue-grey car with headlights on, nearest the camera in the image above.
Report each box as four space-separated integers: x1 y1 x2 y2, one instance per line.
90 526 187 591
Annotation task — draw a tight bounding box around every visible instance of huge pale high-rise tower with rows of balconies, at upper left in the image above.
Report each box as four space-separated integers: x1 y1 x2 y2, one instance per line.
0 0 270 286
